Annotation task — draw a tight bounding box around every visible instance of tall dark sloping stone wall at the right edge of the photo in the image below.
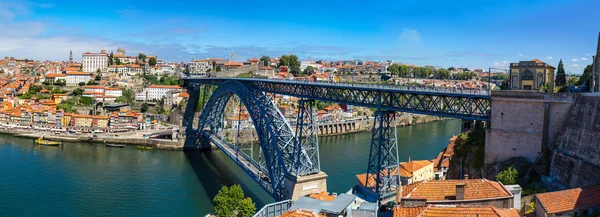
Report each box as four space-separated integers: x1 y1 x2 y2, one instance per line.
548 94 600 188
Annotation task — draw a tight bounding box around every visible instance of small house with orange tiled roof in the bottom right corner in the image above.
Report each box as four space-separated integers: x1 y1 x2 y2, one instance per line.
535 186 600 217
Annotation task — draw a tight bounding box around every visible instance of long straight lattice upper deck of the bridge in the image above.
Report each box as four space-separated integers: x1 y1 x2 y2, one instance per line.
186 78 491 121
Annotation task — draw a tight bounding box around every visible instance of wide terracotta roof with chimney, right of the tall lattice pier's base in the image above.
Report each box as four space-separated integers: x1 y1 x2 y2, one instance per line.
402 179 512 201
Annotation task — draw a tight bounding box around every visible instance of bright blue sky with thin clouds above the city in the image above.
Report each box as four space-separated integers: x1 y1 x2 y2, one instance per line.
0 0 600 74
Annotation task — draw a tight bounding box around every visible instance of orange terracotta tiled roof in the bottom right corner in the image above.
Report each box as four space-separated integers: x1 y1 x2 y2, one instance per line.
535 185 600 214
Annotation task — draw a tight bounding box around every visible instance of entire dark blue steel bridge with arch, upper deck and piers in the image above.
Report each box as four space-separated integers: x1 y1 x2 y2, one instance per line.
184 77 491 201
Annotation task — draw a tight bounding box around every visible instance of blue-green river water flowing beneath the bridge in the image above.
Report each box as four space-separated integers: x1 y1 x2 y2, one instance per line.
0 120 460 216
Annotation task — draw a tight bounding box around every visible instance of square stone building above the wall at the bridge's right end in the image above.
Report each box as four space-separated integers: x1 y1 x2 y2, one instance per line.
509 59 556 90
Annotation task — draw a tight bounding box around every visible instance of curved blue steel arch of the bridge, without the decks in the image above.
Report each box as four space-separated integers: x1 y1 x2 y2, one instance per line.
197 81 318 200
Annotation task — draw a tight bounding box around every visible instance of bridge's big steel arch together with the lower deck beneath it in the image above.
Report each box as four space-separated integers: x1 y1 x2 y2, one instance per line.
186 81 320 200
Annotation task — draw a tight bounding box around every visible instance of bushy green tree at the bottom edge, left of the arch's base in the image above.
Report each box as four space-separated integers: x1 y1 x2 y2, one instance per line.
213 185 256 217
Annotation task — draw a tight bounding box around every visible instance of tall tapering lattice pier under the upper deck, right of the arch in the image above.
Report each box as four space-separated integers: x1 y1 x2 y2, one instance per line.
355 110 400 202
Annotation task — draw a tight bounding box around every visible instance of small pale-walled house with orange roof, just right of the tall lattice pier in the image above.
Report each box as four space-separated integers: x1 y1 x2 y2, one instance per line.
400 158 435 185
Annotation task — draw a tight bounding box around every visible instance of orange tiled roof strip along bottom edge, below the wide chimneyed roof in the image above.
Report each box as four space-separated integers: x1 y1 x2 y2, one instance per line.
394 205 519 217
